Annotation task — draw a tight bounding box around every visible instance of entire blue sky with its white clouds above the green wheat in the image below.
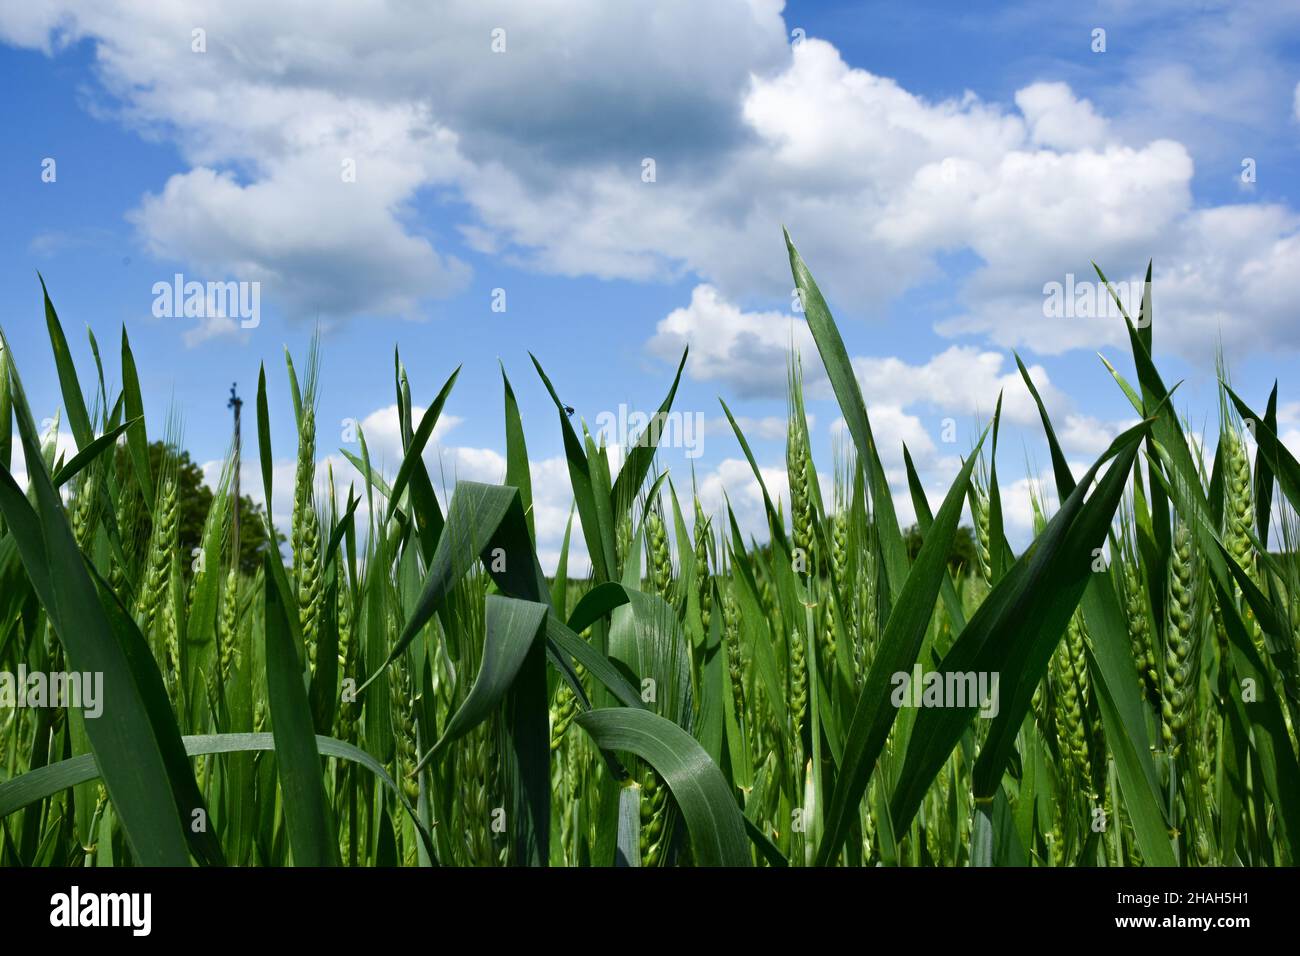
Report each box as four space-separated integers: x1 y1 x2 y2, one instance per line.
0 0 1300 567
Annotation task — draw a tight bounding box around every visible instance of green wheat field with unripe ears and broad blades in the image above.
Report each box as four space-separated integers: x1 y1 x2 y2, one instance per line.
0 237 1300 866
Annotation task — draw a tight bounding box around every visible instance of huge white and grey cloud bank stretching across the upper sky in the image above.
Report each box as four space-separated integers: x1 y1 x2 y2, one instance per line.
0 0 1300 361
